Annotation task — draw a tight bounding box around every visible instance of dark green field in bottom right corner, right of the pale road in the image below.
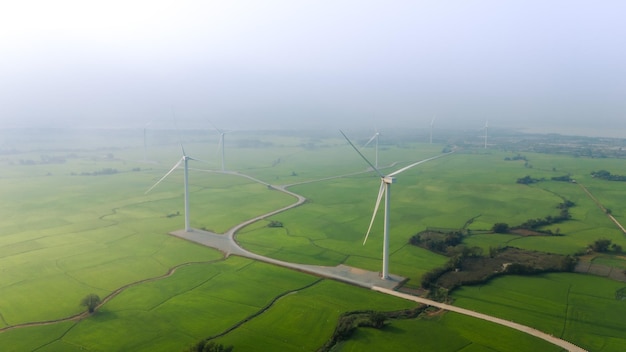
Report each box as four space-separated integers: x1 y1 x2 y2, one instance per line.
453 274 626 351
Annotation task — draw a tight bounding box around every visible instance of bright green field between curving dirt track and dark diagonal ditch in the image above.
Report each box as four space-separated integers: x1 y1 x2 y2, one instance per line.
1 257 316 351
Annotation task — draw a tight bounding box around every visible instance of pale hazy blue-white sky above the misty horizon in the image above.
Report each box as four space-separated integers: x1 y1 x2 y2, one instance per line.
0 0 626 133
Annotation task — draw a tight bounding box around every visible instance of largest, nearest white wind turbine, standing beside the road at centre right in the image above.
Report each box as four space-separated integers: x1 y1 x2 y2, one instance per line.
339 130 450 280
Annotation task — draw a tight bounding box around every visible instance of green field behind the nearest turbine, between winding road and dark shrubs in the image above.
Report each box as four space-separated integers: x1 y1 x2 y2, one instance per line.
238 148 624 279
